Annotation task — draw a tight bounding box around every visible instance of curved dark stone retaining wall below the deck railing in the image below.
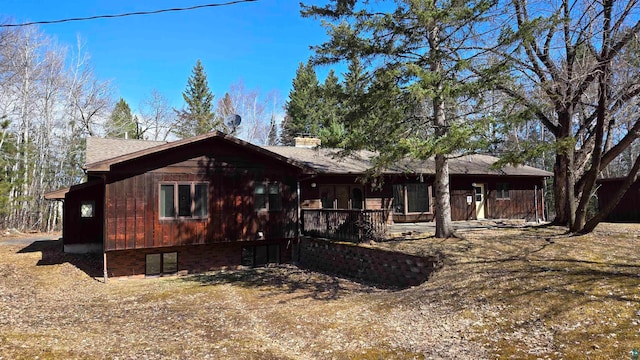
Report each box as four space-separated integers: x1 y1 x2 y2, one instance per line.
298 237 442 288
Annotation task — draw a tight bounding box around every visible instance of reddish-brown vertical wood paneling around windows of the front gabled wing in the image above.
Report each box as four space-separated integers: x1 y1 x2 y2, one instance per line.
108 155 304 249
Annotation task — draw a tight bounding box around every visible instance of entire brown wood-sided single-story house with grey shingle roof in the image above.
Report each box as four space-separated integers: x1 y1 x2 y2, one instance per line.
48 132 551 279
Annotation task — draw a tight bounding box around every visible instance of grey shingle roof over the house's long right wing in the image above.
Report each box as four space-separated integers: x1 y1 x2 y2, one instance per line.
264 146 553 177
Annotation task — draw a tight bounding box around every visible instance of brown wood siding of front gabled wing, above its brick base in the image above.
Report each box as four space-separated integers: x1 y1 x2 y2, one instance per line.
105 141 298 251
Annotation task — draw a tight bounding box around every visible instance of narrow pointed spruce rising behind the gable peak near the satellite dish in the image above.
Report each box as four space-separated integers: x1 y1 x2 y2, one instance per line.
175 60 218 138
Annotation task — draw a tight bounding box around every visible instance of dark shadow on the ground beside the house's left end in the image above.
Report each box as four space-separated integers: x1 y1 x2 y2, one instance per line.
18 239 102 277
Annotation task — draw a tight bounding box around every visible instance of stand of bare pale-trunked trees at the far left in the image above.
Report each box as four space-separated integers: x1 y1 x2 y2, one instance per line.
0 27 109 230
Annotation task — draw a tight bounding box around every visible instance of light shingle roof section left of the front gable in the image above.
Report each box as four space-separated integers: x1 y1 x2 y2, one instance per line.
85 136 167 165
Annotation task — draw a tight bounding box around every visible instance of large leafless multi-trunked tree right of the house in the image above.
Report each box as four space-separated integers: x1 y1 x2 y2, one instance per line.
500 0 640 232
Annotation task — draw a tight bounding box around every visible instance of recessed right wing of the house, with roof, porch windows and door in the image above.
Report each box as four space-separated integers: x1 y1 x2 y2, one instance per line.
264 146 553 222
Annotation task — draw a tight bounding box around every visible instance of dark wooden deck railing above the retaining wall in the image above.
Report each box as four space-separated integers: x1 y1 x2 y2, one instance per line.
302 209 388 242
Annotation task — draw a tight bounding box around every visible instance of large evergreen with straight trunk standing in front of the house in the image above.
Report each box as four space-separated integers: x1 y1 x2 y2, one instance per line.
302 0 494 237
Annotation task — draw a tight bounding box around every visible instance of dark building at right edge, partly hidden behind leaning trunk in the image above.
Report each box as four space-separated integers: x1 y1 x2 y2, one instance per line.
597 178 640 222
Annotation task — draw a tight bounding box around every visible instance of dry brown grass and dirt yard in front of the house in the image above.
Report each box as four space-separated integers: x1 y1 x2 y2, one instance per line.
0 224 640 359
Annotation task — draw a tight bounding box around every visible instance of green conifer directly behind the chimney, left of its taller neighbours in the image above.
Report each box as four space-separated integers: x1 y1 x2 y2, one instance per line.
280 62 321 145
